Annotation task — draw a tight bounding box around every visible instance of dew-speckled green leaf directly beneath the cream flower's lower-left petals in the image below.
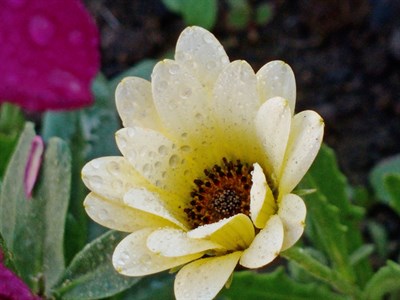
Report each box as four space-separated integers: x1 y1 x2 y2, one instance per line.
54 231 140 300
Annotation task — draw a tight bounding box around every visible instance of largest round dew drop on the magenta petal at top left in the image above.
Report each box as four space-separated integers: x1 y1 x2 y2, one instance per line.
28 15 55 46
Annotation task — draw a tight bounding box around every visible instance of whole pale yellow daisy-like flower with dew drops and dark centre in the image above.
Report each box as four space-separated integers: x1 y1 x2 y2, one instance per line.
82 27 324 299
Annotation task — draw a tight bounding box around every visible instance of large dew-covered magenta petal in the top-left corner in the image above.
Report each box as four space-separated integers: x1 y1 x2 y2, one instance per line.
0 0 100 111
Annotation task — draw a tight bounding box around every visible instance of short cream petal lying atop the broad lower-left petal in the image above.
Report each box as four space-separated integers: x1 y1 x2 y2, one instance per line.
147 228 222 257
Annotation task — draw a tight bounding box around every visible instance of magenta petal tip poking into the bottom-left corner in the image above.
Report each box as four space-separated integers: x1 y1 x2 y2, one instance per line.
0 248 40 300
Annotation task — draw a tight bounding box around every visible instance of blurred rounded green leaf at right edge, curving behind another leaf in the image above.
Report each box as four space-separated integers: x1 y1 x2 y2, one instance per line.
369 154 400 203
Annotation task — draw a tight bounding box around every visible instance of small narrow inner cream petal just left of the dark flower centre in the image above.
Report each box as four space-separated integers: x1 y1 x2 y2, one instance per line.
124 188 187 229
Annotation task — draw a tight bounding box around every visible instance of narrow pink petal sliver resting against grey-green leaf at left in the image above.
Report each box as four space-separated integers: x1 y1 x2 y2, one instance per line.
24 135 44 198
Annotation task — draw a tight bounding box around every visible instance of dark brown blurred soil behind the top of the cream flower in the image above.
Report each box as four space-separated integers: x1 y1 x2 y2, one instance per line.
85 0 400 184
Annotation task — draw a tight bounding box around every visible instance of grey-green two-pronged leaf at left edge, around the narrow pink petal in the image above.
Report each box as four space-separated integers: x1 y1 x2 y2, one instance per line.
0 123 71 293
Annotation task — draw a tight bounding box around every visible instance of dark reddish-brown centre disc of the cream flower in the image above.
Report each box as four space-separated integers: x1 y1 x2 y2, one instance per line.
184 158 253 228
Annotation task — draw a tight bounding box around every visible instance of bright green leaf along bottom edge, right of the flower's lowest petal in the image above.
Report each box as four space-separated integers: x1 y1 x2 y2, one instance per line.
217 268 345 300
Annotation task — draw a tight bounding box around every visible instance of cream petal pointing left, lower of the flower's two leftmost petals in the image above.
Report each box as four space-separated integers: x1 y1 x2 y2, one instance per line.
83 193 173 232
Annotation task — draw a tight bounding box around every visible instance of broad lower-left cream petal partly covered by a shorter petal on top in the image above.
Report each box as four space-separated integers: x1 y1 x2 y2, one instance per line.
112 228 203 276
